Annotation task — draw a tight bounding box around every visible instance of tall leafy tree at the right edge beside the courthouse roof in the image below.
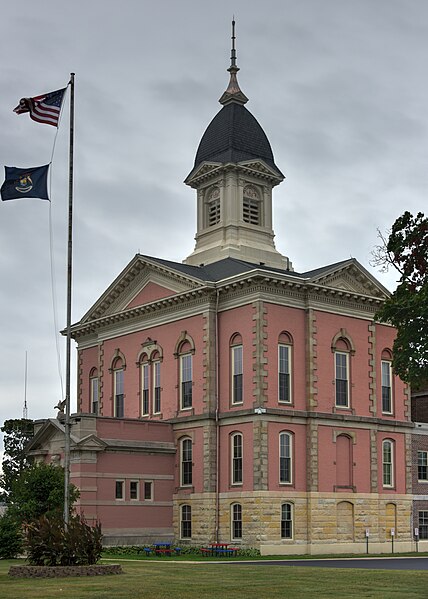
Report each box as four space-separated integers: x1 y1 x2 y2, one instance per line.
373 212 428 388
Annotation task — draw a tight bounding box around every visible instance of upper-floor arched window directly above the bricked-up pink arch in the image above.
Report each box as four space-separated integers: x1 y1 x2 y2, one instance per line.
331 336 355 408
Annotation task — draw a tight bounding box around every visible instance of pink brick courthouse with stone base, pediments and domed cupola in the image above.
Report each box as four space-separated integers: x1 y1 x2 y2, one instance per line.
26 36 414 554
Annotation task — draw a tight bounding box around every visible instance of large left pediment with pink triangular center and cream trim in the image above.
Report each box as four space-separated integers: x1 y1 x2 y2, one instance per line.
80 255 204 324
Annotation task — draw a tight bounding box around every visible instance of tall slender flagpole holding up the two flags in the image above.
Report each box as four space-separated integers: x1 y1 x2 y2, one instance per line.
64 73 74 524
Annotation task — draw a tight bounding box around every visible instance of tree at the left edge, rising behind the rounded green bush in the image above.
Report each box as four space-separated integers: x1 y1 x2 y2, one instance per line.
0 418 34 503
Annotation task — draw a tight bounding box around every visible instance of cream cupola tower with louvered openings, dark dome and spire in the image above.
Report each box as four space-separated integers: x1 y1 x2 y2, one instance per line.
184 21 292 270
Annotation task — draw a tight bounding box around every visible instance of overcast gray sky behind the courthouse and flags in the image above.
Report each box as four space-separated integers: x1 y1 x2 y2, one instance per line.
0 0 428 446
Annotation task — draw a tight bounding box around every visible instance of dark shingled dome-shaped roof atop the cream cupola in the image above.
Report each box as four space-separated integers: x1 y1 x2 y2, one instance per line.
194 102 283 176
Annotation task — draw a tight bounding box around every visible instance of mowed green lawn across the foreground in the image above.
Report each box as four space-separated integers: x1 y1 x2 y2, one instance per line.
0 560 428 599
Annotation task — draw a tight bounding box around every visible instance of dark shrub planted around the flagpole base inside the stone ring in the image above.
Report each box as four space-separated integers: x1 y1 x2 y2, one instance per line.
26 514 102 566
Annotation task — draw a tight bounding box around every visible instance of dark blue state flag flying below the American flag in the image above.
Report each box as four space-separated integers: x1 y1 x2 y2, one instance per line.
0 164 49 201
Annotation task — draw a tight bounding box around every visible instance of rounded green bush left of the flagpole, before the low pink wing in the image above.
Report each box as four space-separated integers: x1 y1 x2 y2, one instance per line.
8 462 79 522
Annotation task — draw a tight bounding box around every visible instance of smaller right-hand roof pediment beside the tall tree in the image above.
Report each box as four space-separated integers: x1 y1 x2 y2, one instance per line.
310 258 389 299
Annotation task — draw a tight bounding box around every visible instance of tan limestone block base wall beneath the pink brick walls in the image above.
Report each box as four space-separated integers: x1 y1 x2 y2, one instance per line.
174 491 412 555
